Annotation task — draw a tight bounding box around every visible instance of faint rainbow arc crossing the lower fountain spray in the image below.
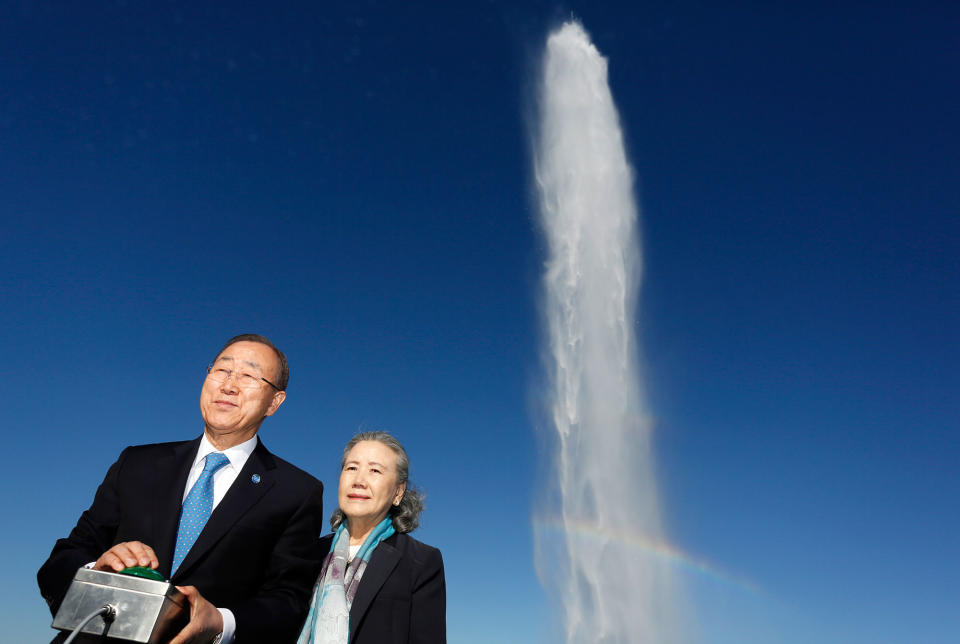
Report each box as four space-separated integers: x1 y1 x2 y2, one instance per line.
533 516 763 595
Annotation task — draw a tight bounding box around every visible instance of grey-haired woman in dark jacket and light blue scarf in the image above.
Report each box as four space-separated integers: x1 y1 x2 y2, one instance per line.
298 432 447 644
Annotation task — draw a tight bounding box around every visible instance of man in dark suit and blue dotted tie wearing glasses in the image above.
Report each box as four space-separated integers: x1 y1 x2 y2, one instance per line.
37 334 323 644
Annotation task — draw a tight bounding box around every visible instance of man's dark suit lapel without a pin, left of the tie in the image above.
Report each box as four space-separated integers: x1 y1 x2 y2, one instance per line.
156 438 200 577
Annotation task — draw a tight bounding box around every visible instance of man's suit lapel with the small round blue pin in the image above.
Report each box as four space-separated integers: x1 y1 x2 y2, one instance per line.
171 441 277 577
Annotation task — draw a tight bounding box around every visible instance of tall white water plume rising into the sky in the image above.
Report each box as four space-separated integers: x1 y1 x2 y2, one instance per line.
534 22 680 644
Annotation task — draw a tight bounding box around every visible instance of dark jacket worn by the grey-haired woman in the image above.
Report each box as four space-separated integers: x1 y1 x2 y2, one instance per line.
320 533 447 644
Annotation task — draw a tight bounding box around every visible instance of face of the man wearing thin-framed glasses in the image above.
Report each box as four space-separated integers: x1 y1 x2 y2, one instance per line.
200 342 286 445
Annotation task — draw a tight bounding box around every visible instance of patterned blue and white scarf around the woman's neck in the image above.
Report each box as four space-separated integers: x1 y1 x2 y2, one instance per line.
297 517 396 644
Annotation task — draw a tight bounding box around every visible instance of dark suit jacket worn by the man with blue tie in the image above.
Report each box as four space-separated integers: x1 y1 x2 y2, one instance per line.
37 438 324 644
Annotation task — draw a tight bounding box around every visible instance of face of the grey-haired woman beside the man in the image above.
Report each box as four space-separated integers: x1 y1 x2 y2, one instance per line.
337 441 406 525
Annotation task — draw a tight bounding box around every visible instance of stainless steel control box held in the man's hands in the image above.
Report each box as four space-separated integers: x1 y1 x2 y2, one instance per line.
53 568 190 644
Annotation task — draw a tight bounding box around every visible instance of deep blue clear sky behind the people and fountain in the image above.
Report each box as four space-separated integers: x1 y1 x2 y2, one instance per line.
0 2 960 644
